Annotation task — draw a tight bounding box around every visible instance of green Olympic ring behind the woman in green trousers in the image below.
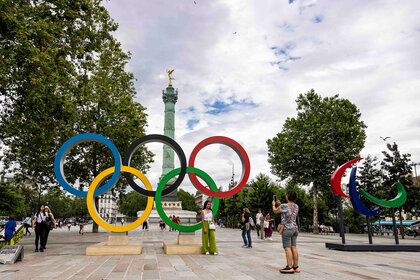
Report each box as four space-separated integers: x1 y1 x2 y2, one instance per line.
155 167 220 232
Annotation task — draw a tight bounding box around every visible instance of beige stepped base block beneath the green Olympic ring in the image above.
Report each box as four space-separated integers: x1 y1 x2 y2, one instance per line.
163 233 202 255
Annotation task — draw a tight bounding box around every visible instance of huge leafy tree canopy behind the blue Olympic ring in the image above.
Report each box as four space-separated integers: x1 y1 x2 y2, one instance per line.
0 0 152 231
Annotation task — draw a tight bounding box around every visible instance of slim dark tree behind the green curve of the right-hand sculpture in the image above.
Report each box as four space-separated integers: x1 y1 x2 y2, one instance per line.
381 142 418 238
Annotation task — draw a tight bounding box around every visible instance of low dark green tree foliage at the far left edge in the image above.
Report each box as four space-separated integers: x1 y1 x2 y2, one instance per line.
0 182 29 220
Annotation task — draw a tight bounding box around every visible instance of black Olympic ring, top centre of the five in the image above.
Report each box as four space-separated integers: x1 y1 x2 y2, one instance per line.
123 134 187 197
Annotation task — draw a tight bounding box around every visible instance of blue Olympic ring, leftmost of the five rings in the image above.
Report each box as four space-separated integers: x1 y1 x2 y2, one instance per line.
54 133 121 197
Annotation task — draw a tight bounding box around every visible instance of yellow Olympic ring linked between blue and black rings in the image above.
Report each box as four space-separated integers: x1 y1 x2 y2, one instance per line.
86 166 155 232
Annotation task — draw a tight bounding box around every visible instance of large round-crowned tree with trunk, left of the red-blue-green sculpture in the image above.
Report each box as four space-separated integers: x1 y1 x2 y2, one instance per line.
267 89 366 232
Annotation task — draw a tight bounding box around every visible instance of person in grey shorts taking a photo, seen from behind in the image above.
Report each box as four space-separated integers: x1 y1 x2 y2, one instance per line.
273 190 300 273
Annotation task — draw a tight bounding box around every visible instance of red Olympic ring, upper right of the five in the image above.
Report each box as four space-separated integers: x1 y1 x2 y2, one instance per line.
188 136 251 198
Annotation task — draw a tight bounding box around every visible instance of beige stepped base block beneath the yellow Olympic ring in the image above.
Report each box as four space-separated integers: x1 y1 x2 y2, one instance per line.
86 235 143 256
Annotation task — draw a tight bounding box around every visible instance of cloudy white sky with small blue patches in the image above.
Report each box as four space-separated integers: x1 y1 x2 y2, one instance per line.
105 0 420 195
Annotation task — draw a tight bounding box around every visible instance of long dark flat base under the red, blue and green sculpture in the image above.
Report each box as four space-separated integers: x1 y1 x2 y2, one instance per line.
325 243 420 252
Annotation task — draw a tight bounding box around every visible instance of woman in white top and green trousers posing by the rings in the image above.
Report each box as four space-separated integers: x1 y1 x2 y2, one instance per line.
201 200 218 255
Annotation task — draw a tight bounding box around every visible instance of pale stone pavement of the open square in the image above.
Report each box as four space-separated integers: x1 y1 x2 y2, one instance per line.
0 224 420 280
